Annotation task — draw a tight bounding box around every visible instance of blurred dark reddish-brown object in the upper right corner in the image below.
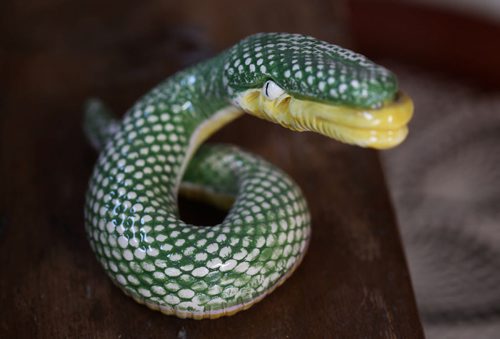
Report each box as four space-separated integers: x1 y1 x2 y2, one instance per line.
347 0 500 89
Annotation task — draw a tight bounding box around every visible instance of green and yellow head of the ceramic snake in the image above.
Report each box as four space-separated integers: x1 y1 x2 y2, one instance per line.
223 33 413 149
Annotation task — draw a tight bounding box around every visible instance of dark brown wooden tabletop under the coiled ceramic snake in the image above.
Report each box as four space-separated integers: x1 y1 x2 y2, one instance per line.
0 0 422 338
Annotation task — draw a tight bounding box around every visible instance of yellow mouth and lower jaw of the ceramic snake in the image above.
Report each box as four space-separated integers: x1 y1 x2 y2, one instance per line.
235 89 413 149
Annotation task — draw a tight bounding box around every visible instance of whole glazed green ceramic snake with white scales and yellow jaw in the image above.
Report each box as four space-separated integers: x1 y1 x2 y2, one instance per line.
85 33 413 319
